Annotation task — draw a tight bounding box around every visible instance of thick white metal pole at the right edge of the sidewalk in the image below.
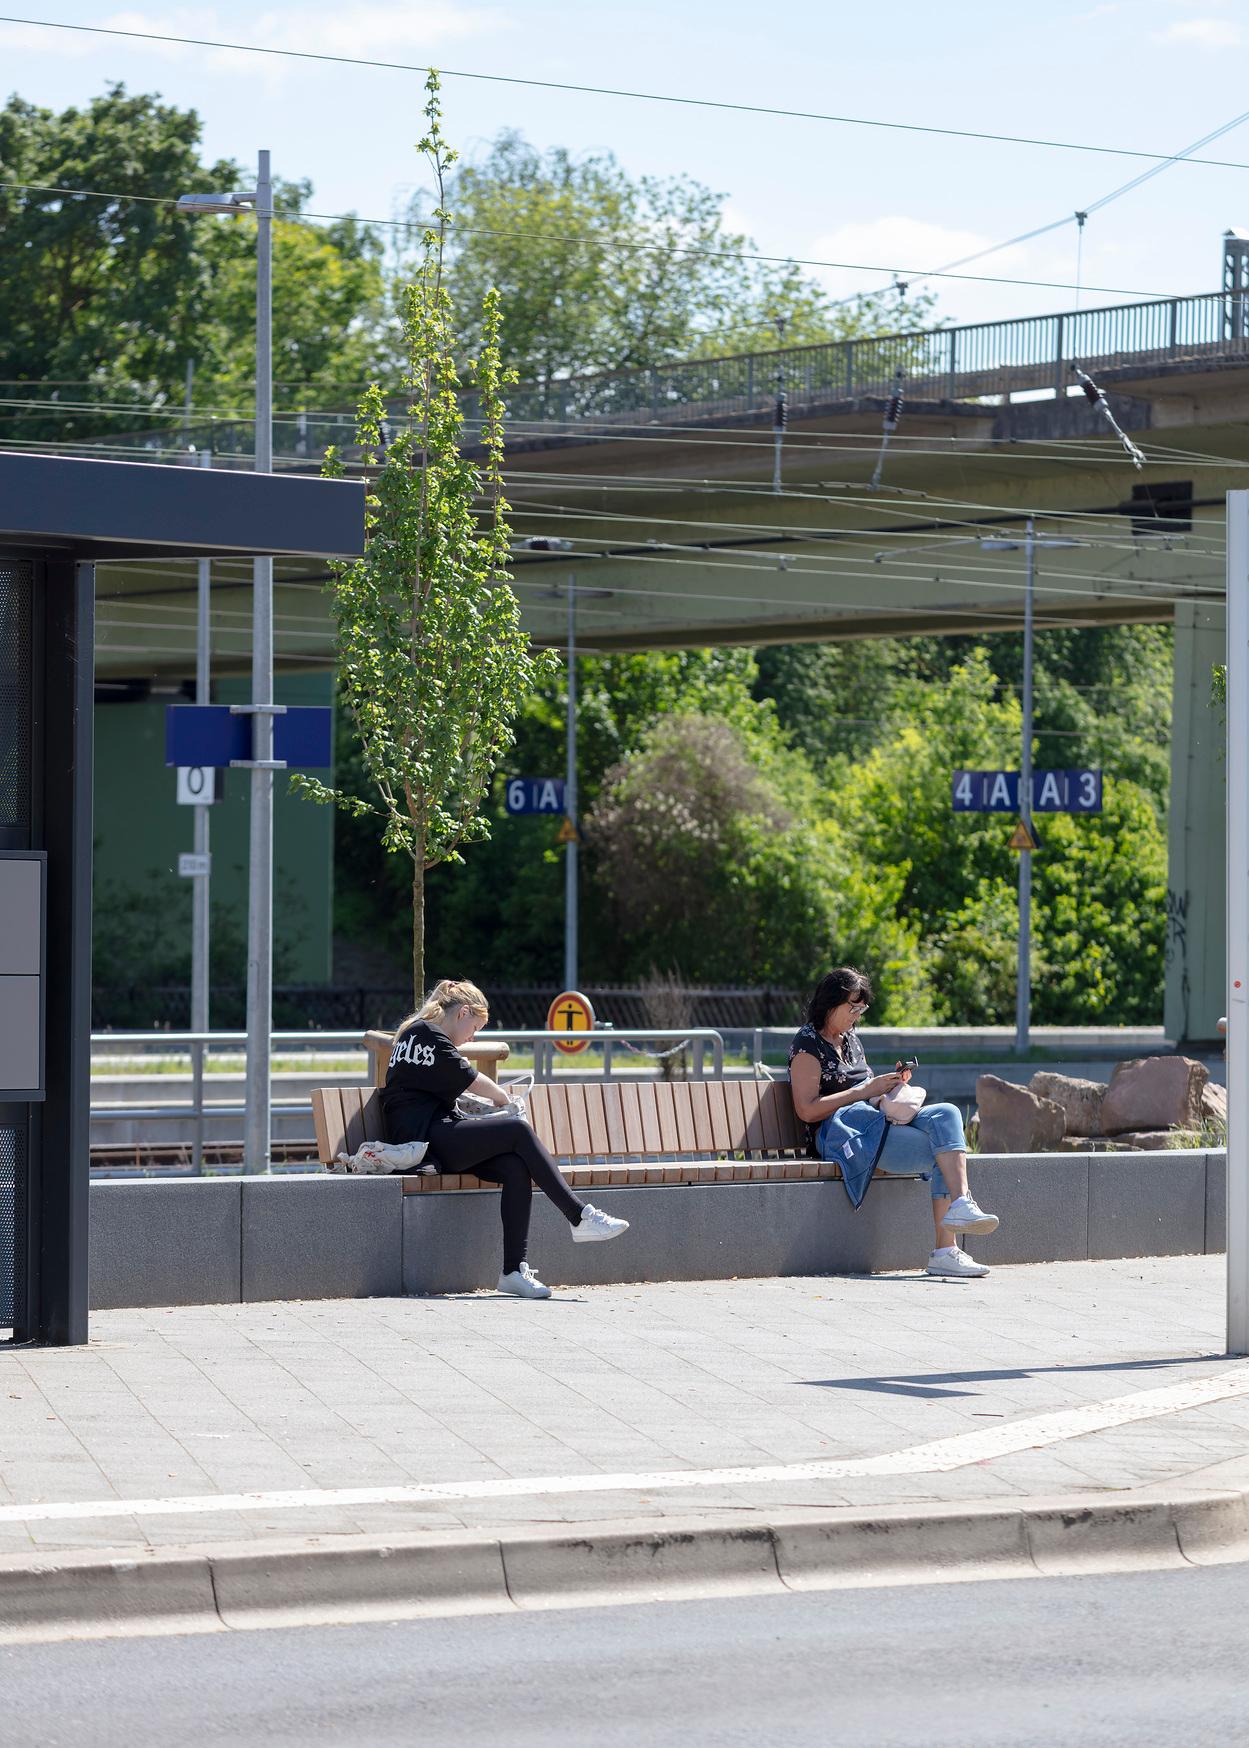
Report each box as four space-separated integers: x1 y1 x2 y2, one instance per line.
1226 491 1249 1353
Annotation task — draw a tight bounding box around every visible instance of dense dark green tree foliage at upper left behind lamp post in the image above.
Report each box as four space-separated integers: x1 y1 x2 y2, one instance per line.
0 86 384 439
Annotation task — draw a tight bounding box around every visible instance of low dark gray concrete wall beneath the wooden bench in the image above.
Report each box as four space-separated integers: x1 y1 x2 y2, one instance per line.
91 1150 1226 1309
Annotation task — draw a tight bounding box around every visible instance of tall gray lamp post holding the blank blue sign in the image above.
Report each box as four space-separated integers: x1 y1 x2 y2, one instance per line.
243 152 273 1175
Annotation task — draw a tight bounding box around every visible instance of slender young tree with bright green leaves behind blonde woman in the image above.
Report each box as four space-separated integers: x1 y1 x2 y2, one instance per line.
293 73 554 1002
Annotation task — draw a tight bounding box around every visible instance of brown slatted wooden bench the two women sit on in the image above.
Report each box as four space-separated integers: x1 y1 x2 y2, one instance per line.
313 1080 915 1196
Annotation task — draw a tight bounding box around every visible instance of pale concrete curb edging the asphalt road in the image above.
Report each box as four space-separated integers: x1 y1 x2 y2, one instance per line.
0 1491 1249 1645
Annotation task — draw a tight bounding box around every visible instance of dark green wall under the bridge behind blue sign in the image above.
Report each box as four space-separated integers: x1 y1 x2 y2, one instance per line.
94 673 334 986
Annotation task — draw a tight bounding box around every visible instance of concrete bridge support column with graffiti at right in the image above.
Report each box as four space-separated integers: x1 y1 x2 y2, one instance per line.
1163 601 1226 1044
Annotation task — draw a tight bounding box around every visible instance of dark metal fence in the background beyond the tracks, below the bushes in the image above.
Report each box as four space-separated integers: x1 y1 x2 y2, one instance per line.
91 984 809 1033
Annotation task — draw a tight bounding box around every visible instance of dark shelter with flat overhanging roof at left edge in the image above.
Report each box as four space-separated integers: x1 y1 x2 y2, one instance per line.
0 454 363 1342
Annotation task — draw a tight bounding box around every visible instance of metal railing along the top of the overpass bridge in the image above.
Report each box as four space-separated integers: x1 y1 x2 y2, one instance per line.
73 292 1249 465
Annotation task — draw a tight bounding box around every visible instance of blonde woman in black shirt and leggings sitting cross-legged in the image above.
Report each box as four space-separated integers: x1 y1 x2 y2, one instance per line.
381 977 629 1299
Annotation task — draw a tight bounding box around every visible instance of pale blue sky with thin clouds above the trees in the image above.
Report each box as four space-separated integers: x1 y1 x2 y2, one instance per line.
0 0 1249 337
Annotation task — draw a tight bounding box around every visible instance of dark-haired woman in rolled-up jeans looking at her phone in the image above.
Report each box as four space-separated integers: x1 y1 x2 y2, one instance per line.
790 967 997 1280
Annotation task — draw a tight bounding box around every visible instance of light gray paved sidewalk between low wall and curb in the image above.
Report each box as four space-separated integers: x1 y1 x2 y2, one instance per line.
0 1257 1249 1556
